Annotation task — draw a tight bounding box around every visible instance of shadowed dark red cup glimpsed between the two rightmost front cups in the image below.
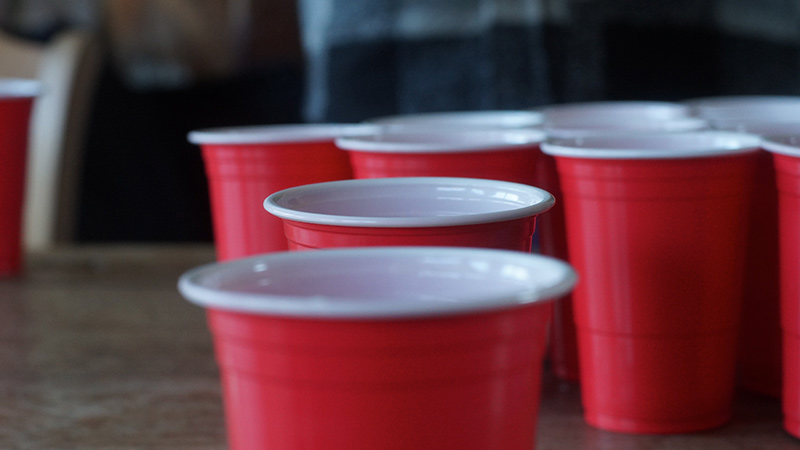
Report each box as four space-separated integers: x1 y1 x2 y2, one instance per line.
711 118 800 397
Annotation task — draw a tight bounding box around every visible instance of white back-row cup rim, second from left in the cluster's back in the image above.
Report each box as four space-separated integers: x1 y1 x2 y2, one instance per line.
365 110 544 129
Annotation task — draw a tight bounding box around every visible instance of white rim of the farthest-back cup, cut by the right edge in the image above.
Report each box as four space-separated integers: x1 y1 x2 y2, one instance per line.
684 95 800 121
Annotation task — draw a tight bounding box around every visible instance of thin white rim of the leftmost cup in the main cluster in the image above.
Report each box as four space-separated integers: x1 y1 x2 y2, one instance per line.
187 123 375 145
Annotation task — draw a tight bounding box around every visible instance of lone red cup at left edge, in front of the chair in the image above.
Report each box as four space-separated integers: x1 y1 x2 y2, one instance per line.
0 78 41 276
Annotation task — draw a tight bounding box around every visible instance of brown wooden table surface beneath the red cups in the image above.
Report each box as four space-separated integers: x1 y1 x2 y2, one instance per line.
0 245 800 450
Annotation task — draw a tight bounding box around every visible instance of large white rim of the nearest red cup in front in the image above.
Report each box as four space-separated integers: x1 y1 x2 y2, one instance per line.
178 247 577 320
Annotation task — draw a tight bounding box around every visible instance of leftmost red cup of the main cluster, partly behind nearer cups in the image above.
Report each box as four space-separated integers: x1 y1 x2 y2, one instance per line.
189 124 370 261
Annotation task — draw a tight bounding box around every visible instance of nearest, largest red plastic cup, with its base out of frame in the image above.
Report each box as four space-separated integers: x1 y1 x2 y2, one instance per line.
178 247 575 450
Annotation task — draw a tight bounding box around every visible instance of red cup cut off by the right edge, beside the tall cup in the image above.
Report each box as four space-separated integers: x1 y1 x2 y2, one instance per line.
762 133 800 438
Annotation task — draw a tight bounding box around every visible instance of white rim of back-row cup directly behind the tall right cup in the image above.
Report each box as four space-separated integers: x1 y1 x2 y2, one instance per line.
538 100 690 122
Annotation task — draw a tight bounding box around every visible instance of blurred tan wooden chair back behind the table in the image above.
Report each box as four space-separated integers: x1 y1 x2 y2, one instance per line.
0 31 102 250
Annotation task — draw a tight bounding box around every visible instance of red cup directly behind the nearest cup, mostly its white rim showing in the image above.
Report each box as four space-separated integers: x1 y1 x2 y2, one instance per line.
264 177 555 252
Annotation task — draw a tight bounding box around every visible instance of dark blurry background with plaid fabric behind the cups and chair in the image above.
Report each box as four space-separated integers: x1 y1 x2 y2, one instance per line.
0 0 800 242
